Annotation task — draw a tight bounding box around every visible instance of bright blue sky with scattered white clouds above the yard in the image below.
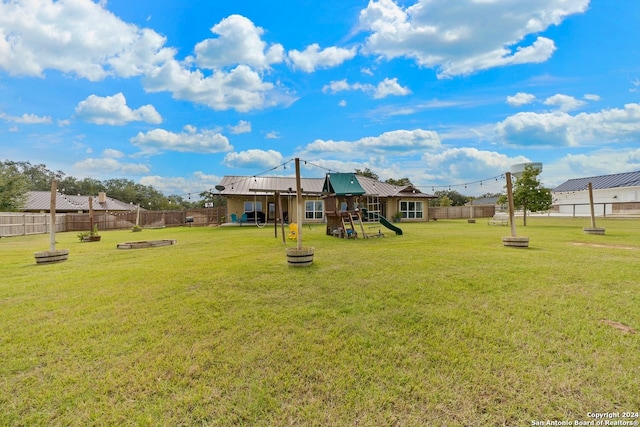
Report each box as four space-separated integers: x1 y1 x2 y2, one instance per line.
0 0 640 195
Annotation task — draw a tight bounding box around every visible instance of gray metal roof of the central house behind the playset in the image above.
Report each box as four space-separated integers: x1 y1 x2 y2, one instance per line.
220 175 434 198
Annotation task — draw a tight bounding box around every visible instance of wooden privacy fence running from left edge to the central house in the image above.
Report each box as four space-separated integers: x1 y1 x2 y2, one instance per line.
0 208 226 237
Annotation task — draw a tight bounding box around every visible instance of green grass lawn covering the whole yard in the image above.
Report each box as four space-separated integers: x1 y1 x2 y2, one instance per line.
0 217 640 426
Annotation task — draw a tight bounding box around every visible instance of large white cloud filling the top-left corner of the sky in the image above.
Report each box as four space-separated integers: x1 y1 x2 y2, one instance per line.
0 0 174 81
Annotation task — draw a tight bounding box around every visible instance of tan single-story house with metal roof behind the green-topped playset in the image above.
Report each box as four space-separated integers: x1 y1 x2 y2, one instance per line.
220 173 435 223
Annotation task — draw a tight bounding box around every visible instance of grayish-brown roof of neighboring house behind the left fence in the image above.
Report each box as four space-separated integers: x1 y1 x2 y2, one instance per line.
24 191 136 213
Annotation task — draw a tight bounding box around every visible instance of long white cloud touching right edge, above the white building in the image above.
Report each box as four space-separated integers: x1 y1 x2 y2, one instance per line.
495 103 640 147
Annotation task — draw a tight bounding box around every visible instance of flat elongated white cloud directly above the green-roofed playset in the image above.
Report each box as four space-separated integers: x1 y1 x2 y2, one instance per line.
304 129 440 158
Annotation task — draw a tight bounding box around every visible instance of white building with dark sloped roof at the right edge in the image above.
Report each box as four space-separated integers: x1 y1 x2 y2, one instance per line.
551 171 640 216
